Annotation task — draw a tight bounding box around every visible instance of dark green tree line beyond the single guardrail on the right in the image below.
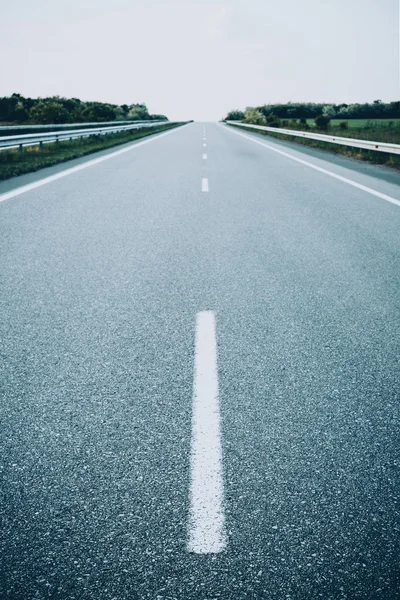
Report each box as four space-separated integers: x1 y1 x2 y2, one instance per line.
225 100 400 125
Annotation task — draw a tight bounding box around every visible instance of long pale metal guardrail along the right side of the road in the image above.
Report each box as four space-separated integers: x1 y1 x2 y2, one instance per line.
225 121 400 154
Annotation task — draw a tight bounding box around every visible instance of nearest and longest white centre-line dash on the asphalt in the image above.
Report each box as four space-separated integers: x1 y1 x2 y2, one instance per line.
188 311 226 554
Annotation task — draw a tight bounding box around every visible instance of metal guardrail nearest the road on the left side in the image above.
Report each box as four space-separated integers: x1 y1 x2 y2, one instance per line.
0 121 175 150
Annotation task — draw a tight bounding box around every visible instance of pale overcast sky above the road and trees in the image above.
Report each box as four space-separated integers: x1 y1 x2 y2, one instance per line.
0 0 400 121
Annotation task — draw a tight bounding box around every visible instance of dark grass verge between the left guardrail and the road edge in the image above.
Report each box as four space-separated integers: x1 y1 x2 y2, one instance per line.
0 123 184 181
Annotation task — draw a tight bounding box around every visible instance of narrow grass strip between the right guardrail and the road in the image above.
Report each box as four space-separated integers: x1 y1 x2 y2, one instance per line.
228 125 400 169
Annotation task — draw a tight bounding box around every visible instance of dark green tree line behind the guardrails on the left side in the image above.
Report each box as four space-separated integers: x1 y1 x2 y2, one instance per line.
0 94 168 125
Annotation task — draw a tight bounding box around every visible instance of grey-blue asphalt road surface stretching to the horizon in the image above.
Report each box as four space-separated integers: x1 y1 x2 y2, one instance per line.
0 123 400 600
